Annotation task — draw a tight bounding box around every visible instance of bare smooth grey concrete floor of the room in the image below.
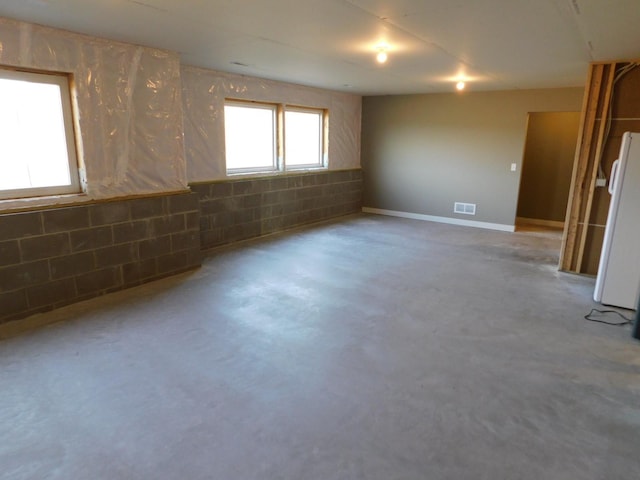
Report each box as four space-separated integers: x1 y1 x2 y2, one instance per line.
0 215 640 480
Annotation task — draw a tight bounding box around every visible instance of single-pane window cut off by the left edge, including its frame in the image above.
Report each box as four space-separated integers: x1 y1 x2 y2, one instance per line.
0 69 80 199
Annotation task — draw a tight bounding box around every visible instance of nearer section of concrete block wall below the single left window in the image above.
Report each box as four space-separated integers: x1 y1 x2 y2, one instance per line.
0 193 201 323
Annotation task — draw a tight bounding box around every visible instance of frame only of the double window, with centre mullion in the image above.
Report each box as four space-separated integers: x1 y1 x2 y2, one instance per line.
224 99 329 175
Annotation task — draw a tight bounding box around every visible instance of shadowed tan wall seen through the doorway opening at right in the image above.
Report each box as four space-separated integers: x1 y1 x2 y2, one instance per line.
518 112 580 222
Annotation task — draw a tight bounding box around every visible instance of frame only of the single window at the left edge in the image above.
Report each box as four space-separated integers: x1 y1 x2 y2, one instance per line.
0 67 81 200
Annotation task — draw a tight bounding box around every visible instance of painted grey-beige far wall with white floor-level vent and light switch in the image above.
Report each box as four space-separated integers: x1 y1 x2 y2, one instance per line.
362 88 583 226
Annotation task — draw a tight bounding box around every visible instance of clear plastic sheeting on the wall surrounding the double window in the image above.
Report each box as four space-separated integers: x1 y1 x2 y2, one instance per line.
181 66 362 182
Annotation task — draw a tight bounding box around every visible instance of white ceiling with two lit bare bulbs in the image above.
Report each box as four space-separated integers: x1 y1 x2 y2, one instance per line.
0 0 640 95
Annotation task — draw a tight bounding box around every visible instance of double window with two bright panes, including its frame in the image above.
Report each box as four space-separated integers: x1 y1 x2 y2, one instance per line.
224 100 327 174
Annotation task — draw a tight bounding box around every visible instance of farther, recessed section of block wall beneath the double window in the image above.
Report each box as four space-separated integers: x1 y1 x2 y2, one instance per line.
191 169 362 249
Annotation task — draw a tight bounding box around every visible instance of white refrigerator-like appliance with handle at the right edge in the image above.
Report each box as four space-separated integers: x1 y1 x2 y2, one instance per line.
593 132 640 310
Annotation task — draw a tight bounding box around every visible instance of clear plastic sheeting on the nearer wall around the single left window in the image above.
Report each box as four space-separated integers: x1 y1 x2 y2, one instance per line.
0 18 187 205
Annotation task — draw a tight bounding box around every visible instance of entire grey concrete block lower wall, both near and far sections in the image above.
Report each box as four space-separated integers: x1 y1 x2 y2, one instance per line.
0 169 362 323
